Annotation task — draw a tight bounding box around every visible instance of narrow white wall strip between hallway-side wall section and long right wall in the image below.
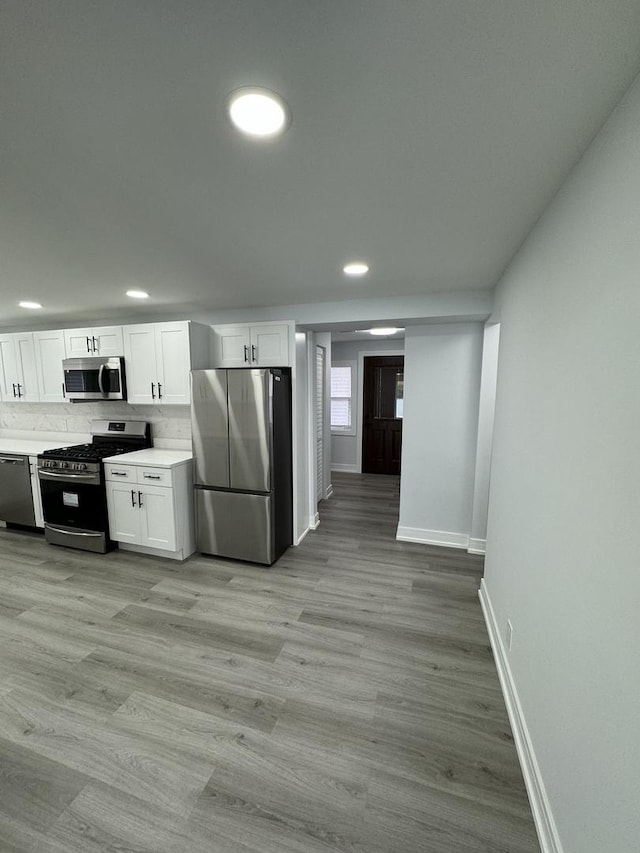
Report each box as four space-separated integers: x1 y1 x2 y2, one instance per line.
469 323 500 554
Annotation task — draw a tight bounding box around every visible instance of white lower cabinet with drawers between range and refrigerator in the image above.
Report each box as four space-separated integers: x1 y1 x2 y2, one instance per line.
105 462 195 560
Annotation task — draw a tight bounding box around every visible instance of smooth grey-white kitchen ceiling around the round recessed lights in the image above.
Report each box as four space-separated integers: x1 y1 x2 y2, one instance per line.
0 0 640 328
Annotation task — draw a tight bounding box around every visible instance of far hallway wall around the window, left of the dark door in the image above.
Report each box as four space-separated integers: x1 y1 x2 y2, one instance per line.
329 338 404 473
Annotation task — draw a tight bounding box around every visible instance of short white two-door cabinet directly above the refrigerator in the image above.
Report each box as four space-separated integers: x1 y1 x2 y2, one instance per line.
213 323 291 367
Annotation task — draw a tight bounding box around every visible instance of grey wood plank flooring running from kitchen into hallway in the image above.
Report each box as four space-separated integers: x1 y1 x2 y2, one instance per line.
0 474 539 853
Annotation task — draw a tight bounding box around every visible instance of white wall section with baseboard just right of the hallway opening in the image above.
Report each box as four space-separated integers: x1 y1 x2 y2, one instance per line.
398 323 483 548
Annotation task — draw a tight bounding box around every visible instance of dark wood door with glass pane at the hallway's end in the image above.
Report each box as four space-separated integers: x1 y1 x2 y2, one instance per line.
362 355 404 474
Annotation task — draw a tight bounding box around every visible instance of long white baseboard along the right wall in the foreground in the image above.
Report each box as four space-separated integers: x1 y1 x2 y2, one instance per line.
479 578 563 853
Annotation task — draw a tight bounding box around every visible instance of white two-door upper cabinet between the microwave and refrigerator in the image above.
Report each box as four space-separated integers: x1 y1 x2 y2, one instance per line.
124 321 200 405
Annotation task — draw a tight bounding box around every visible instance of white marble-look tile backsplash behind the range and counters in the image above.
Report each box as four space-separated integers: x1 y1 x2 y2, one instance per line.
0 402 191 447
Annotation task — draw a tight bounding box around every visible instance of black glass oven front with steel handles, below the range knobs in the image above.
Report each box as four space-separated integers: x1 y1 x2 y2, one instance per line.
38 468 111 553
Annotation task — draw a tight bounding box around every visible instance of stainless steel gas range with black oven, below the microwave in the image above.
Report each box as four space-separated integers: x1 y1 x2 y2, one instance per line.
38 420 151 554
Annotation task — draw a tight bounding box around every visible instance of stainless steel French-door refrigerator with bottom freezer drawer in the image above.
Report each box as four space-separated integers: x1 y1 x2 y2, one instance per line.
191 368 293 565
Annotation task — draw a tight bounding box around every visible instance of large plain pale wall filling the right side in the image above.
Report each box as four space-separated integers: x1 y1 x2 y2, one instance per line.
485 71 640 853
